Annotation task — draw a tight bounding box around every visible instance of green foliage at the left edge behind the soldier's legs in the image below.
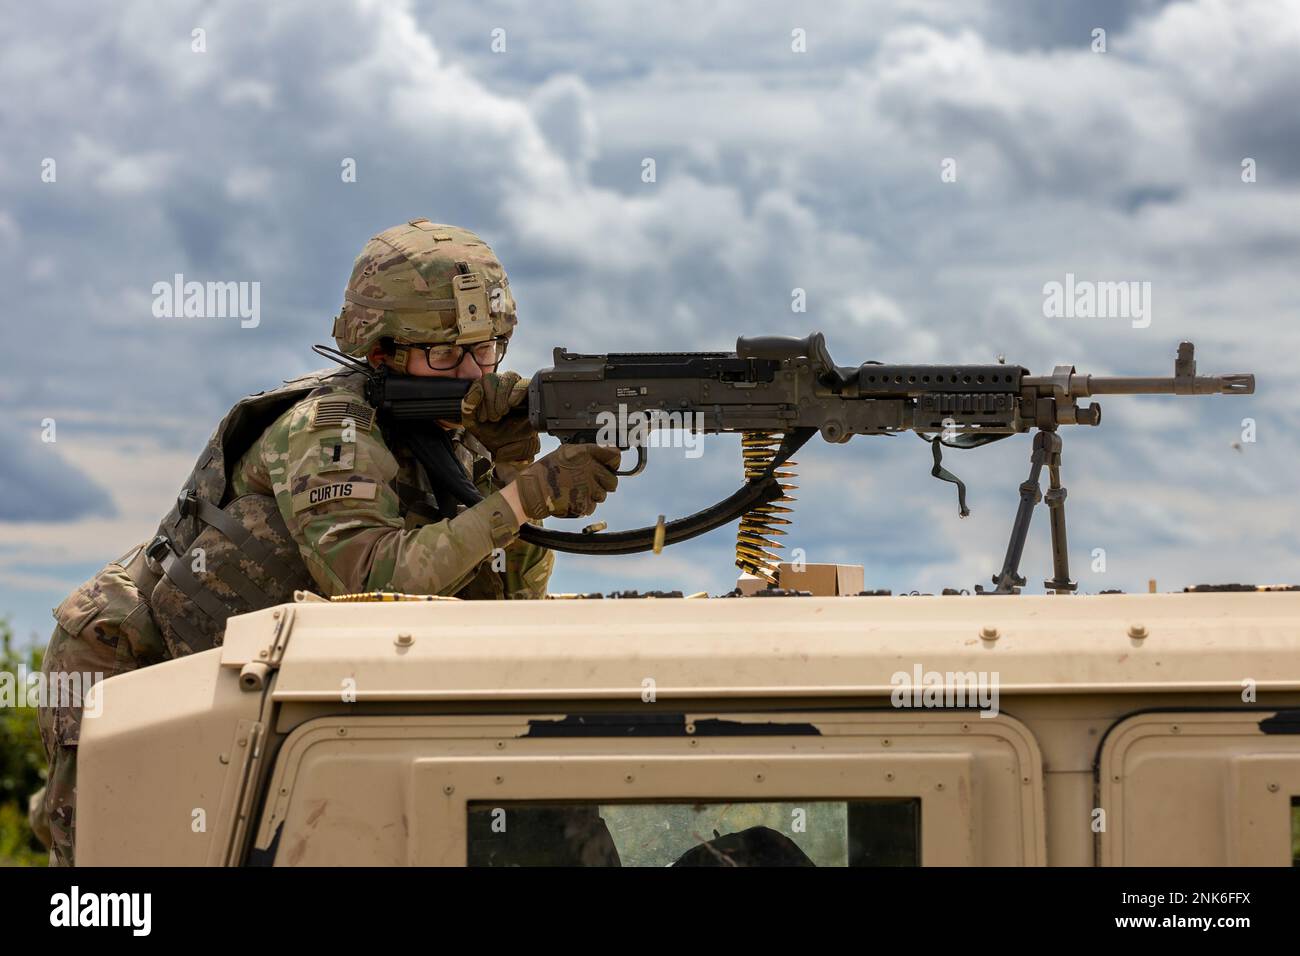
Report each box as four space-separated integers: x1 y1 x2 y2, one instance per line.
0 620 48 866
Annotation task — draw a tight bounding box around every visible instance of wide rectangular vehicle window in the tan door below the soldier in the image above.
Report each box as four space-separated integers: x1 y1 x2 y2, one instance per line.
467 797 920 866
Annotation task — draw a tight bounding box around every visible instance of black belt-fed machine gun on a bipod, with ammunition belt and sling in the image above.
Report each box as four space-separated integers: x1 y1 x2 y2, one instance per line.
343 333 1255 594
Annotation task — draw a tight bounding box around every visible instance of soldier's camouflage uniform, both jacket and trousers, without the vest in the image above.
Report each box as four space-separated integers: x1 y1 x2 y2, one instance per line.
33 376 554 864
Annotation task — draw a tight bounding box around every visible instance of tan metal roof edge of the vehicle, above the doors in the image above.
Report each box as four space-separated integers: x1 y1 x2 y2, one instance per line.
221 592 1300 702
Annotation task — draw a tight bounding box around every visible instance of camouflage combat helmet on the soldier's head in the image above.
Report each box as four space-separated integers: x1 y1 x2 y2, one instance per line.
334 219 516 367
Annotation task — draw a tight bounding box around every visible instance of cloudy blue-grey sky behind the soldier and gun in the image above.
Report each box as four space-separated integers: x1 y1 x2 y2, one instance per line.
0 0 1300 639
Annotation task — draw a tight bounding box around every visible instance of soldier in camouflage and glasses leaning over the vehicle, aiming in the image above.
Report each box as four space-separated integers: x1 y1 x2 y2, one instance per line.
33 219 619 865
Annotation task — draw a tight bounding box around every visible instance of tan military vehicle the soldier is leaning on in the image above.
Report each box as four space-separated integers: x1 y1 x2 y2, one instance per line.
77 580 1300 866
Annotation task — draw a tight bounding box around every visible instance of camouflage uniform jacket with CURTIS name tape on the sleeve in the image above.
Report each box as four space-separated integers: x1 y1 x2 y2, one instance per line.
231 371 555 598
